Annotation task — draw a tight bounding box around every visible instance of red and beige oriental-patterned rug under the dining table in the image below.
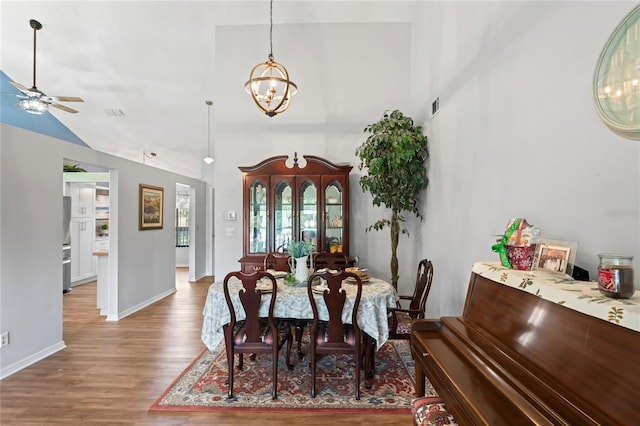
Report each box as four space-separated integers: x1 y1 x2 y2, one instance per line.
149 340 436 414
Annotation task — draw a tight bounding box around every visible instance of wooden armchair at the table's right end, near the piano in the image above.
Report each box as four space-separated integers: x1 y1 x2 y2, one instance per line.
388 259 433 340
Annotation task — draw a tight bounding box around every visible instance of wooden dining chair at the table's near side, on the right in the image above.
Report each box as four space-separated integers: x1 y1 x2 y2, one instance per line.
307 271 371 399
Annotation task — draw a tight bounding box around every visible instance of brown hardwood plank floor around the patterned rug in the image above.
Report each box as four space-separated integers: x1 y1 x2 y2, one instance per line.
0 268 413 426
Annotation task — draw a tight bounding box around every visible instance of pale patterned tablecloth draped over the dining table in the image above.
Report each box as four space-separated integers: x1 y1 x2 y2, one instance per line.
201 276 400 350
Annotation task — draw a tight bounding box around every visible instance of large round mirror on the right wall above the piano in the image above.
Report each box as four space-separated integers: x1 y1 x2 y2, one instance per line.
593 5 640 140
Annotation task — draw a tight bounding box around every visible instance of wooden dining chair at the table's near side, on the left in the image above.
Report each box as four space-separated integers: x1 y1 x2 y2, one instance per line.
223 271 293 399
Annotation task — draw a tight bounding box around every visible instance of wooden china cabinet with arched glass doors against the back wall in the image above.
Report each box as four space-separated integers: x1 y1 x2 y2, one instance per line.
239 153 352 271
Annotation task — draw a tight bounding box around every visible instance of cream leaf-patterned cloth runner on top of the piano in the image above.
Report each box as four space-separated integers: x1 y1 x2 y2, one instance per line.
473 262 640 331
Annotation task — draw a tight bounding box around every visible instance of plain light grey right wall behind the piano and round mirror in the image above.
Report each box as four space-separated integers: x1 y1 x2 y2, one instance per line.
413 1 640 316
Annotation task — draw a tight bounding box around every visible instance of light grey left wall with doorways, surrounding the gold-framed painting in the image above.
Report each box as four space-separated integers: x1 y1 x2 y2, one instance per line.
0 125 206 377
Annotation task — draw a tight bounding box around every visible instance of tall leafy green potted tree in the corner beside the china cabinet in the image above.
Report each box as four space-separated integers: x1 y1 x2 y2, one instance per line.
356 110 429 288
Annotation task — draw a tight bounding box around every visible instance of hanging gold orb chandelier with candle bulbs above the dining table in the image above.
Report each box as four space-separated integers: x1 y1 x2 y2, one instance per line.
244 0 298 117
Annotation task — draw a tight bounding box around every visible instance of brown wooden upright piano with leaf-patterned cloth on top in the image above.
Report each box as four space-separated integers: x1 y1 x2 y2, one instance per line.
411 263 640 426
